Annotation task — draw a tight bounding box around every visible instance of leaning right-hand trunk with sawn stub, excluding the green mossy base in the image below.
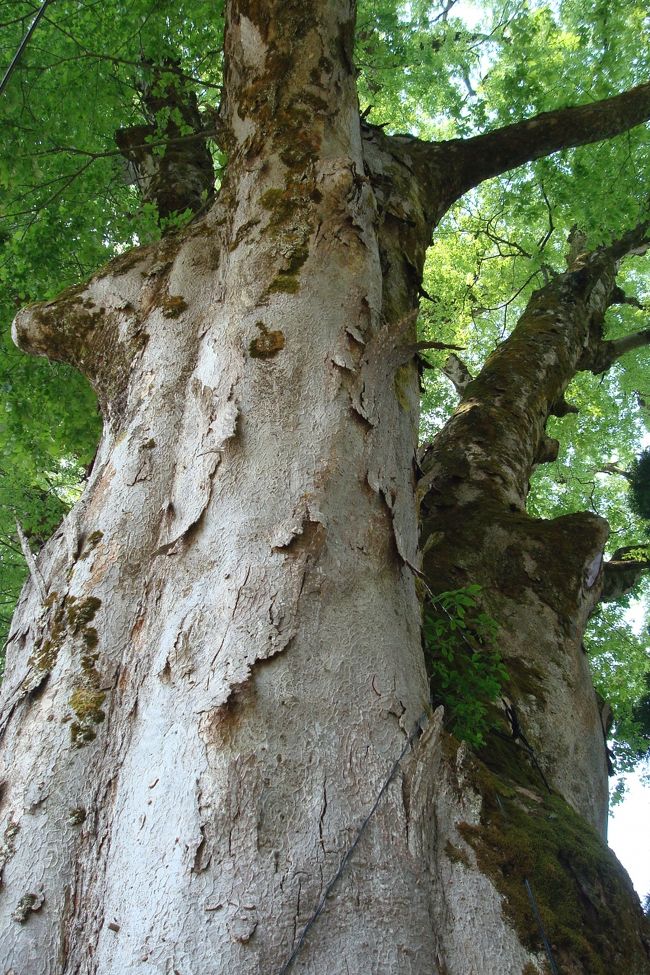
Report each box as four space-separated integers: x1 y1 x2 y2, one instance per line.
420 229 647 835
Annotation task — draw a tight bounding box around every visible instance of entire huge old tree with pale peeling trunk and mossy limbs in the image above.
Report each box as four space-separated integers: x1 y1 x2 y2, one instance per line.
0 0 650 975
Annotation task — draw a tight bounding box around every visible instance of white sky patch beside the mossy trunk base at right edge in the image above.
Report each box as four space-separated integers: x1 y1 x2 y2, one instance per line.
609 775 650 899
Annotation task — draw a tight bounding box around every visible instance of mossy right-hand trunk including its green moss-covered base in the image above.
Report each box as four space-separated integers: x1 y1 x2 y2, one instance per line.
420 242 650 973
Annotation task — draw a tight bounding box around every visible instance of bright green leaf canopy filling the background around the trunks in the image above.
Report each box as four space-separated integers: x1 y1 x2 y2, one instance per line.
0 0 650 768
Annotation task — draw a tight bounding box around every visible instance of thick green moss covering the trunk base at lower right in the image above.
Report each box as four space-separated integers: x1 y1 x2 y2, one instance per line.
459 741 650 975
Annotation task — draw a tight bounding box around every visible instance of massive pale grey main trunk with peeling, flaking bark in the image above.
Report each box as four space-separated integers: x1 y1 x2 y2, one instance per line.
0 0 435 975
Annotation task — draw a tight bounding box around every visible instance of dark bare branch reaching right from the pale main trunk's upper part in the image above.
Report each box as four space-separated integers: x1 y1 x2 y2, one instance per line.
432 84 650 205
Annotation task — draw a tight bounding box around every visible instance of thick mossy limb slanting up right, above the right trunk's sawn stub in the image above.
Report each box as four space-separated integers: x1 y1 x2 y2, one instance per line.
420 227 632 510
